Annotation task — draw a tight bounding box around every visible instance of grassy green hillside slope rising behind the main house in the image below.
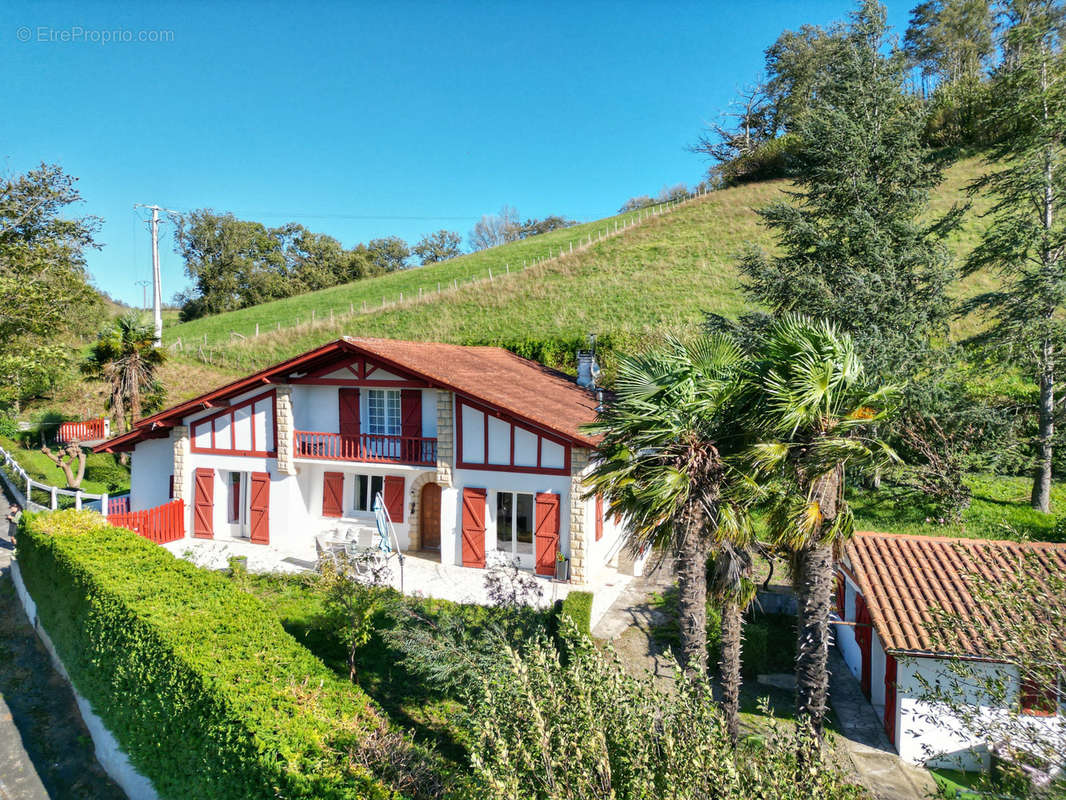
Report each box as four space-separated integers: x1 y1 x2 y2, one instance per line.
166 159 989 381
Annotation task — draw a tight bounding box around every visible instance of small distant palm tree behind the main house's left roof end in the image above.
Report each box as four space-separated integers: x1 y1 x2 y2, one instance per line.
81 311 166 433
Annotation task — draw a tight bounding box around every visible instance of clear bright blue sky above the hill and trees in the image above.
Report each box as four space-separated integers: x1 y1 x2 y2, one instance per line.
0 0 912 304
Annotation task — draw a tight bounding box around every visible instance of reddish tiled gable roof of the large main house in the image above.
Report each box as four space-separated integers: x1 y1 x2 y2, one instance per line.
95 336 597 451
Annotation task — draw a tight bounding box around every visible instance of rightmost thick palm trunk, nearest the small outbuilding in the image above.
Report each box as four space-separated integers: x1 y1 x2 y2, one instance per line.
796 545 833 738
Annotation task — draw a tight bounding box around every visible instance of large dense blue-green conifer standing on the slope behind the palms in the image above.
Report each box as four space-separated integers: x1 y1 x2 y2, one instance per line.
740 2 959 388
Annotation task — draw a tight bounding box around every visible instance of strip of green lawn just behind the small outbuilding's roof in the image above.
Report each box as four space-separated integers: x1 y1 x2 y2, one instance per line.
847 475 1066 542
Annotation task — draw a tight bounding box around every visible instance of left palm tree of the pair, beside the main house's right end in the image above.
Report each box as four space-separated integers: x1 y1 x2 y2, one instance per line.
588 337 741 671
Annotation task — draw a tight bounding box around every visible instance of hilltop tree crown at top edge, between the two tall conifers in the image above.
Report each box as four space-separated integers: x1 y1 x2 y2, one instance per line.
904 0 996 85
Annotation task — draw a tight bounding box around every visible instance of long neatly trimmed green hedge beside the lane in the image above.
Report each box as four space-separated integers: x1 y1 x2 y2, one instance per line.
18 511 407 800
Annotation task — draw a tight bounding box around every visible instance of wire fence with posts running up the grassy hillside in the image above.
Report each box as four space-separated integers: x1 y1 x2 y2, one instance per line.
167 193 707 369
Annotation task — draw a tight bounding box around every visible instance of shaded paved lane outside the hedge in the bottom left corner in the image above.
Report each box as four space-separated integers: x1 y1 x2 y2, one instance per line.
0 494 126 800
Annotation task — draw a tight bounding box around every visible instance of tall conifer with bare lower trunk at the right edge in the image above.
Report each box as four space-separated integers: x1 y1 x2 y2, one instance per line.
965 0 1066 513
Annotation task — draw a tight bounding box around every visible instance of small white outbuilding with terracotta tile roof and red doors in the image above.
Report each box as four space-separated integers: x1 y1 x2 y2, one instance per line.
835 533 1066 770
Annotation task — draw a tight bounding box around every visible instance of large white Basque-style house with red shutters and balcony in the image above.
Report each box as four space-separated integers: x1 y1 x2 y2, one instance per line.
97 337 623 583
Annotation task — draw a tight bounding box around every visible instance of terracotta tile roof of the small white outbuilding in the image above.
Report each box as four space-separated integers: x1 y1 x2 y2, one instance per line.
842 532 1066 657
